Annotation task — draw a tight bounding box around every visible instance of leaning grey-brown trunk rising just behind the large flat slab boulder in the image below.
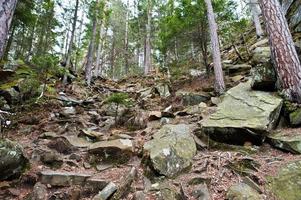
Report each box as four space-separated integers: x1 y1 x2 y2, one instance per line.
205 0 226 94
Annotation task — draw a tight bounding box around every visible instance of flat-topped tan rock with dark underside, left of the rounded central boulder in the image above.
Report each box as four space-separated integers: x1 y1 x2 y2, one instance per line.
89 139 134 163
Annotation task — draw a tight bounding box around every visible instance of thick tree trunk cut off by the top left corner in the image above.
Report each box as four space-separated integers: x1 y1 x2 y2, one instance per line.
0 0 17 58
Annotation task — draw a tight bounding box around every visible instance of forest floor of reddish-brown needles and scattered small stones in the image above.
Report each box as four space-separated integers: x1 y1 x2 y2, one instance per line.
0 72 301 200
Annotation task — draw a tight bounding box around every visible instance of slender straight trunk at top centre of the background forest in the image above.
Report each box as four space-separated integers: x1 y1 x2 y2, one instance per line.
144 0 152 75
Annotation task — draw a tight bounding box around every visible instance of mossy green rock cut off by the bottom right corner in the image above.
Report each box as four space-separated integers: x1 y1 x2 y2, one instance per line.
268 160 301 200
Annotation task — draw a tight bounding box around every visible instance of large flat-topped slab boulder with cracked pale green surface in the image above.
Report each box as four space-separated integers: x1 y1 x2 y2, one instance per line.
201 82 282 145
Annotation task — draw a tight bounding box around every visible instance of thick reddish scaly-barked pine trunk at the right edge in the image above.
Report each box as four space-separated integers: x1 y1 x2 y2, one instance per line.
259 0 301 103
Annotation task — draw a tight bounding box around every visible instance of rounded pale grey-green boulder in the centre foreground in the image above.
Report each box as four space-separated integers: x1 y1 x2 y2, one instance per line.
144 124 196 177
